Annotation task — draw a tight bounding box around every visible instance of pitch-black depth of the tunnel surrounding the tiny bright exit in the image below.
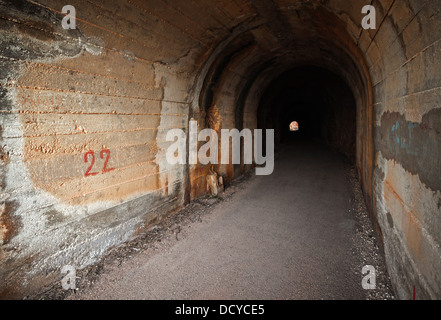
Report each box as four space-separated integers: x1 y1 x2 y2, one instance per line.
258 67 356 163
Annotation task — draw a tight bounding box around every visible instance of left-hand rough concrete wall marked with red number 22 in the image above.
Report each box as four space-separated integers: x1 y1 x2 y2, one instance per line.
0 0 199 297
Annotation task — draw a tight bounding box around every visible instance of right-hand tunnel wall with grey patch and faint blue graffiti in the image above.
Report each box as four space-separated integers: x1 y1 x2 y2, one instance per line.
366 1 441 299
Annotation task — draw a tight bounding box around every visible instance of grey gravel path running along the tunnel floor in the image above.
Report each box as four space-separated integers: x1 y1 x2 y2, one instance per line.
35 139 394 300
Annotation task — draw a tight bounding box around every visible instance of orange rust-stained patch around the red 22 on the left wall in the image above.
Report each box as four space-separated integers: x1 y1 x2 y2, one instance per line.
17 52 165 204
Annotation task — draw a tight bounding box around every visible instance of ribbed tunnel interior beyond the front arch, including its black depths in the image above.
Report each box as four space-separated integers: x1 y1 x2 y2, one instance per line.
198 7 373 190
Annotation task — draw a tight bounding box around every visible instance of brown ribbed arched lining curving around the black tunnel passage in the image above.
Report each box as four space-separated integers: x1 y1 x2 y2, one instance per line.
186 0 374 210
